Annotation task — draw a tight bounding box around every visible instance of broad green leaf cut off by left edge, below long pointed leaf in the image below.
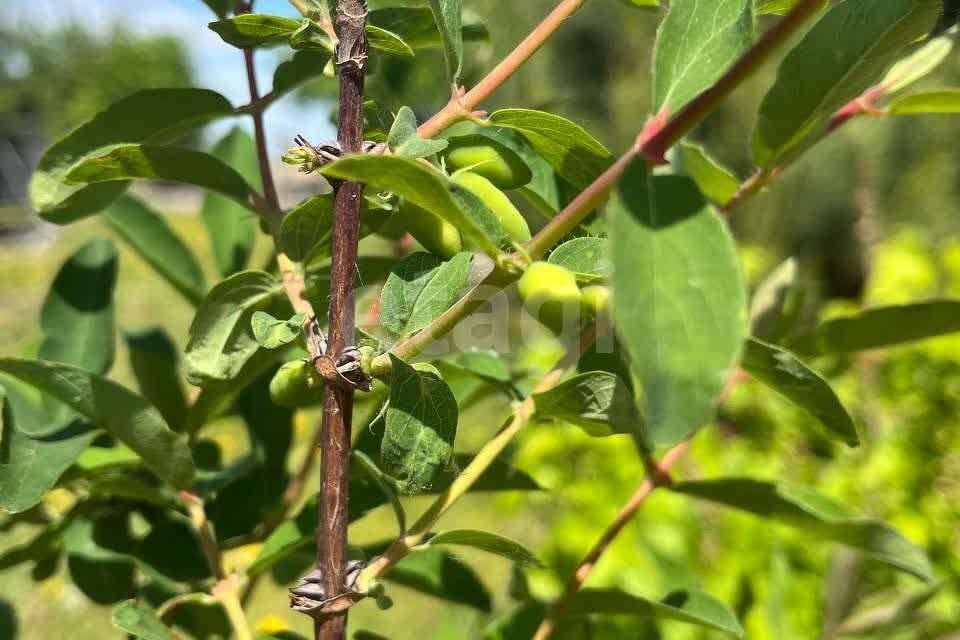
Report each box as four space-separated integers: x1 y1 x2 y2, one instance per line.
0 387 96 513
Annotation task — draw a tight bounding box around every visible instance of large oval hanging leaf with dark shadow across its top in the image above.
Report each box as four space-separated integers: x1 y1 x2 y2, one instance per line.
607 161 746 446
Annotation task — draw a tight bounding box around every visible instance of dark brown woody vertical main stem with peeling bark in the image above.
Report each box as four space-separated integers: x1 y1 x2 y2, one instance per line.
315 0 367 640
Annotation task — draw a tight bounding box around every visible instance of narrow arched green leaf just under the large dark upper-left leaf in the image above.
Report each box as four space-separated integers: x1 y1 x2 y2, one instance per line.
66 144 253 208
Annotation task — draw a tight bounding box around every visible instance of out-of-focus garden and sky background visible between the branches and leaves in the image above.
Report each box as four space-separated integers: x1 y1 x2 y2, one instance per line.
0 0 960 640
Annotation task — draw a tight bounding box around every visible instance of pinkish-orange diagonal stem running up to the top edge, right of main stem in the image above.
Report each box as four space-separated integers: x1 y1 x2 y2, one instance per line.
417 0 585 138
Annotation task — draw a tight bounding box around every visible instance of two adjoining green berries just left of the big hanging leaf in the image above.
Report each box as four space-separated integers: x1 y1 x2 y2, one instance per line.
517 262 610 334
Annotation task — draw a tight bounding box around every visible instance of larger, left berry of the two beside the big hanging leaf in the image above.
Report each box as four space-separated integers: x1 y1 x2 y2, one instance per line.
517 262 583 334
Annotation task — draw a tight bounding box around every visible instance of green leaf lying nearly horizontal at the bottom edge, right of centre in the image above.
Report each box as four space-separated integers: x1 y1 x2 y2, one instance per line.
569 589 743 638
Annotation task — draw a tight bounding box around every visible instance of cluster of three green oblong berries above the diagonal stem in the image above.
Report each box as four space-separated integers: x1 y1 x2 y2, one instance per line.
392 135 533 260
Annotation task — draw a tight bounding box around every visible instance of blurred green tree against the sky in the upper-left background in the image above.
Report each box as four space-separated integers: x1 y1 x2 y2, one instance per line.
0 25 191 138
